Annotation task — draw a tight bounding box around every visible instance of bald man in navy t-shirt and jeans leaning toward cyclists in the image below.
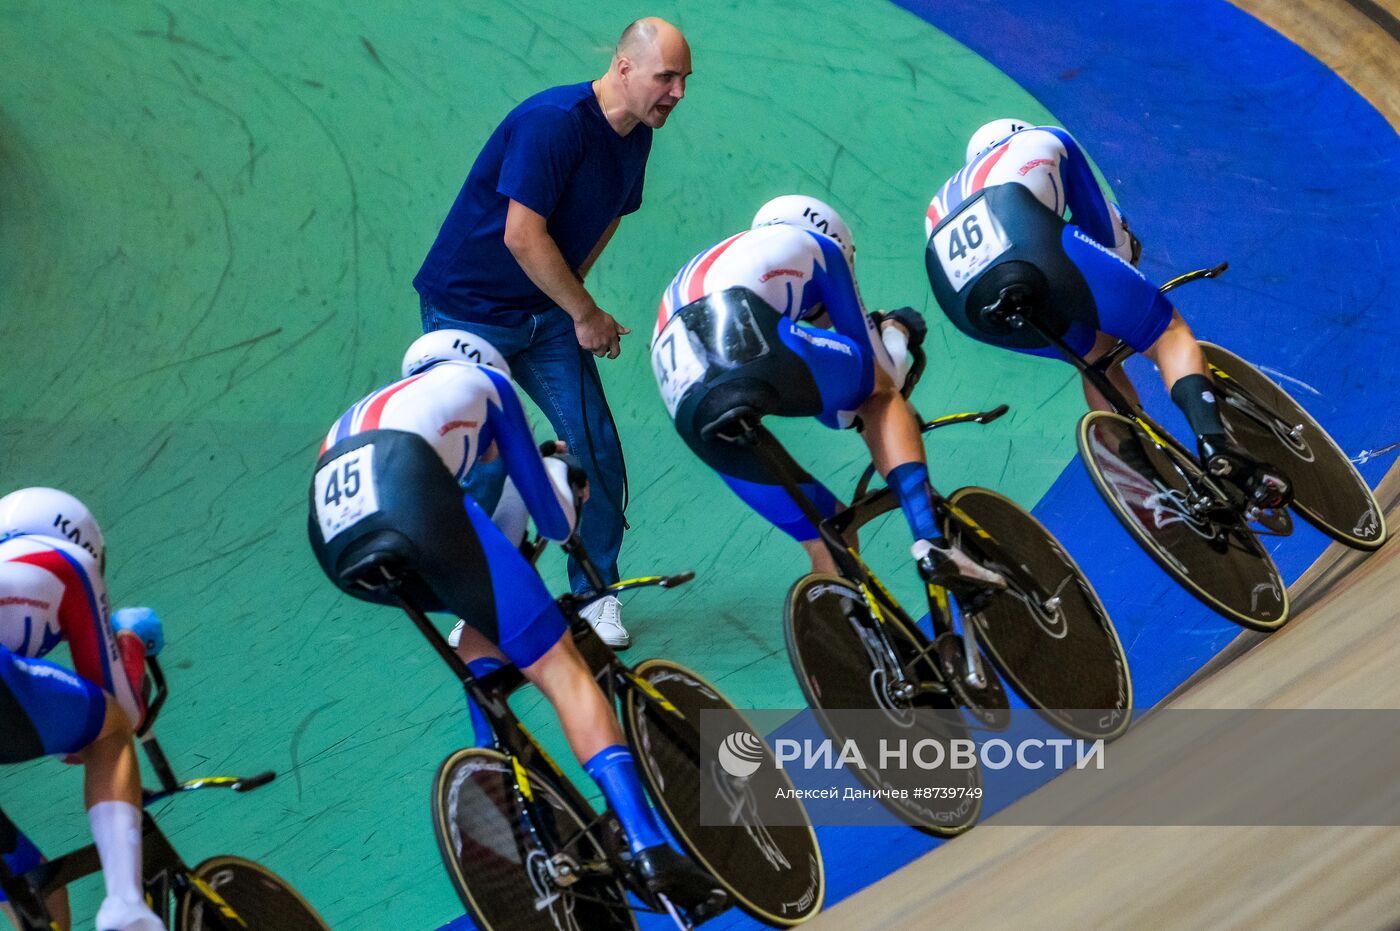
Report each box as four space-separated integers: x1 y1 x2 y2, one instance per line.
413 17 690 647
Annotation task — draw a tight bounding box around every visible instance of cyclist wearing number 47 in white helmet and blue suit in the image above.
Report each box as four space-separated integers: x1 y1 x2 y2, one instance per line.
651 195 1005 588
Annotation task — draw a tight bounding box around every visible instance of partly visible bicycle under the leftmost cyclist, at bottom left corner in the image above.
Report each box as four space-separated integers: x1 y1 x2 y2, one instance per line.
0 657 329 931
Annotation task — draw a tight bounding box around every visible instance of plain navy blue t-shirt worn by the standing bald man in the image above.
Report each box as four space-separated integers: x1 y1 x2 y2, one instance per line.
413 83 651 323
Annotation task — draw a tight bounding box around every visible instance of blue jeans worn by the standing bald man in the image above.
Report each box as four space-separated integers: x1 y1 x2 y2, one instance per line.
420 298 623 594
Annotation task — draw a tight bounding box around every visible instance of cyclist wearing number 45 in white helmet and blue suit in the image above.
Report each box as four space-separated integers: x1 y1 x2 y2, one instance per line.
308 329 727 917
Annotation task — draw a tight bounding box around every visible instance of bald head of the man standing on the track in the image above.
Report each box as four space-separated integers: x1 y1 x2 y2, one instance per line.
602 17 690 130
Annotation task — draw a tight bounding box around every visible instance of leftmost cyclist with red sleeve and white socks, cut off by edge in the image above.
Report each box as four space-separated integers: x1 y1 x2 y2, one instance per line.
0 487 165 931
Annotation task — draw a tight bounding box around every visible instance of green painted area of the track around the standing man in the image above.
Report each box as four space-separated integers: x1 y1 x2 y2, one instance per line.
0 0 1082 930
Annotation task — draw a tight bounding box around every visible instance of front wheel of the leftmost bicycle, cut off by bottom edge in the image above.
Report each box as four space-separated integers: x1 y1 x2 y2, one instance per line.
175 857 329 931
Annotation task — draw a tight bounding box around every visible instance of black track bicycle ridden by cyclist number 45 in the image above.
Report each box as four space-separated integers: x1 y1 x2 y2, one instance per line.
330 539 826 931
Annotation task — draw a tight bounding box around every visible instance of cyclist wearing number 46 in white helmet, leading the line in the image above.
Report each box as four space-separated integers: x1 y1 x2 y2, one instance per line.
924 119 1288 507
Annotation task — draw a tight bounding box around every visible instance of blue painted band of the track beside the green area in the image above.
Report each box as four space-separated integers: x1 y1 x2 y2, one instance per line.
452 0 1400 928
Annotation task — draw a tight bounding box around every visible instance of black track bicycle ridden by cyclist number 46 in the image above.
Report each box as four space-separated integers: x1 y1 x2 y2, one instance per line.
981 262 1386 631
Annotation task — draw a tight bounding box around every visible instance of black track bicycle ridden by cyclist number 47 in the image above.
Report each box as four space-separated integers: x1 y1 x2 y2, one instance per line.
706 350 1133 837
